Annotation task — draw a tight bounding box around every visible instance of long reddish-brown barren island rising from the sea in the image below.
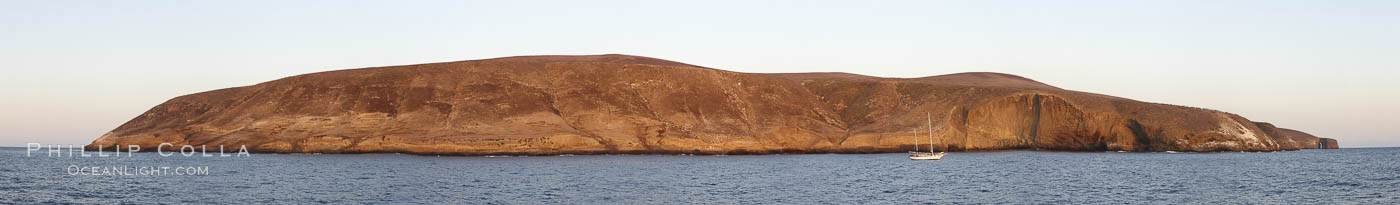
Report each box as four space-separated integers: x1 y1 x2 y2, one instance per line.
90 55 1336 154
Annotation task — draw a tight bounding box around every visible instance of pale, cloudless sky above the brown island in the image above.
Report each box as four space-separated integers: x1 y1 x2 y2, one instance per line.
0 0 1400 147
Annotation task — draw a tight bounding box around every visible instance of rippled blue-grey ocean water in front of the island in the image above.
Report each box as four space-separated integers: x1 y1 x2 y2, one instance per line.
0 147 1400 204
